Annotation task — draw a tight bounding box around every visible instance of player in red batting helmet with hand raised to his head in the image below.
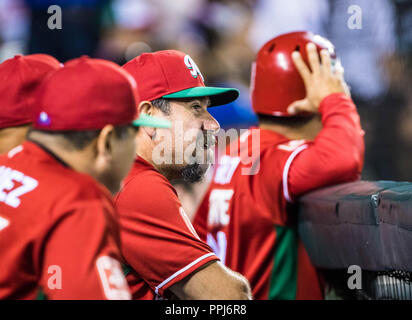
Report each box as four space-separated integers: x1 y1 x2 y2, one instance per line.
193 32 364 300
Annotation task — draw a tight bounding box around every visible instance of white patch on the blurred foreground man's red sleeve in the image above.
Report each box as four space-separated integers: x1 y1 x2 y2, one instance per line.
96 256 131 300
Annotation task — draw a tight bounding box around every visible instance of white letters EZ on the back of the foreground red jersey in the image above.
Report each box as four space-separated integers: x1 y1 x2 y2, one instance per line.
0 166 39 208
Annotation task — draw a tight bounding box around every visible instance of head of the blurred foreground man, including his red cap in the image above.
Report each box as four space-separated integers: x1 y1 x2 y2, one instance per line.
28 57 144 193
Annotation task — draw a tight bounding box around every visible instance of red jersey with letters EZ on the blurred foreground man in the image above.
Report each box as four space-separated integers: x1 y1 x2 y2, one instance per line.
0 142 131 299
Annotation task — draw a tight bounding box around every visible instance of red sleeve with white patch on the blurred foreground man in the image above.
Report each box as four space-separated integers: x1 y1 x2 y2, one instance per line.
40 200 131 300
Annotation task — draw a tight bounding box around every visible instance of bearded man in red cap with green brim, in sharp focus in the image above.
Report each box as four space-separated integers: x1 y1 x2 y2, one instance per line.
115 50 250 299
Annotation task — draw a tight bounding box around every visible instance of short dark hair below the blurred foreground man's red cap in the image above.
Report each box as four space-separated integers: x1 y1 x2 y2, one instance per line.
27 125 130 150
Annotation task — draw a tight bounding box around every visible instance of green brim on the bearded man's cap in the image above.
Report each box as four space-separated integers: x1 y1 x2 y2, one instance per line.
162 87 239 107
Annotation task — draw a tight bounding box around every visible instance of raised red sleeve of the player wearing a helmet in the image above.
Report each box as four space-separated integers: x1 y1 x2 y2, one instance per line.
283 94 364 201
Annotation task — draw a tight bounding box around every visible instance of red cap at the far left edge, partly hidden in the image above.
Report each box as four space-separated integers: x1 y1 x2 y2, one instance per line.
0 54 62 128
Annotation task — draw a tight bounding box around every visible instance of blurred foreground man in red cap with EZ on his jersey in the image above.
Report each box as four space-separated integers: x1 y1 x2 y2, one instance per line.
0 57 170 299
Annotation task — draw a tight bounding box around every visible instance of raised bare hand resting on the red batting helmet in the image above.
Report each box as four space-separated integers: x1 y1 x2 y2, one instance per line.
288 43 350 114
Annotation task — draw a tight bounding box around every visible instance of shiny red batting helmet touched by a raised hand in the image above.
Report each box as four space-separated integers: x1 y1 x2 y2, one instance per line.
251 31 336 117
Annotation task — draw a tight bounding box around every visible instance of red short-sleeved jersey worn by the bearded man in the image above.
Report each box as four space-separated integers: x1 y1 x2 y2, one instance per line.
115 157 218 299
